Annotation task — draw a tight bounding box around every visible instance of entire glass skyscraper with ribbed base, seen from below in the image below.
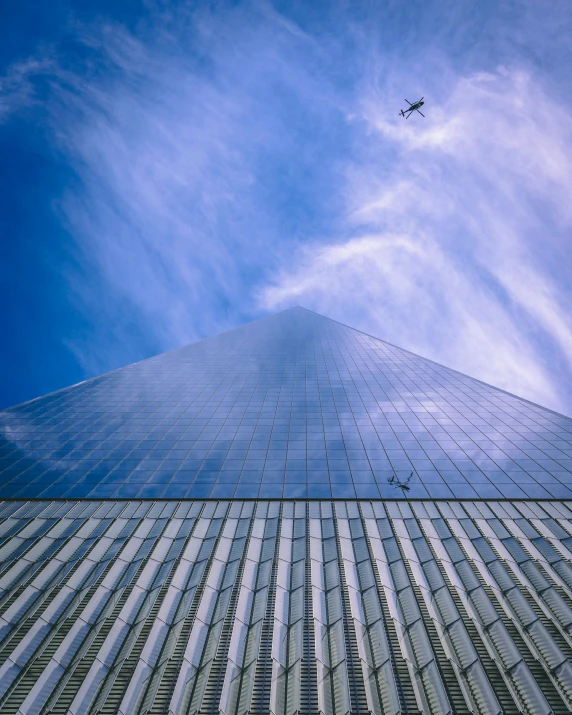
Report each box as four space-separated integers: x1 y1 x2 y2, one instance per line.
0 308 572 715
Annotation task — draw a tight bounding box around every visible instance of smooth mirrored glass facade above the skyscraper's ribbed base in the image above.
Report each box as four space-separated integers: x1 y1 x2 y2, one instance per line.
0 308 572 500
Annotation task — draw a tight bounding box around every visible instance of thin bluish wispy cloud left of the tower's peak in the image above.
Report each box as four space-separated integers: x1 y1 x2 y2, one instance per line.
2 4 345 374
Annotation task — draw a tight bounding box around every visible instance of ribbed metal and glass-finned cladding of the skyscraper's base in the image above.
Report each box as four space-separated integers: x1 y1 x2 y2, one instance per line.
0 500 572 715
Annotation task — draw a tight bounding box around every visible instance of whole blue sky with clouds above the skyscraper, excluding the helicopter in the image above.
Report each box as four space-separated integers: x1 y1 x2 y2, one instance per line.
0 0 572 414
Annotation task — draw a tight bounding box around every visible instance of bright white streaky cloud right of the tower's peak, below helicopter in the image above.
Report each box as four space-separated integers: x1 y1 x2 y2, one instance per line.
261 69 572 412
